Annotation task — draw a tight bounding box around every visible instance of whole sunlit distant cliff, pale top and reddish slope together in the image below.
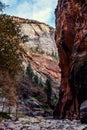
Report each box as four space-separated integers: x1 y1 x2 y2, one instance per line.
12 16 61 98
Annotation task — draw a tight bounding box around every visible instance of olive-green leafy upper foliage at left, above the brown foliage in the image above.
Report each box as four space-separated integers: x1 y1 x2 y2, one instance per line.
0 15 21 74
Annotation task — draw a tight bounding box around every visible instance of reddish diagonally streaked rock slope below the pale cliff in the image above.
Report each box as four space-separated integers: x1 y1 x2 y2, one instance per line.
23 45 61 87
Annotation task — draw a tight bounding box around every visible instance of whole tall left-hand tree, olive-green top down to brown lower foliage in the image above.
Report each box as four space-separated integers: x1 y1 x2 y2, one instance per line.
0 15 22 117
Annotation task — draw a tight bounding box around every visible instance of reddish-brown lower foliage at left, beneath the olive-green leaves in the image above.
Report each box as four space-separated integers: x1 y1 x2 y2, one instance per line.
0 70 17 112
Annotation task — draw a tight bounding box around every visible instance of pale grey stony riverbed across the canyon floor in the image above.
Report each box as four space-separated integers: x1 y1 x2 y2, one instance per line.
0 116 87 130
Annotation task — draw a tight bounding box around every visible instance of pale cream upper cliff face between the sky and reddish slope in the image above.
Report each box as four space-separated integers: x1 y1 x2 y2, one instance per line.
13 17 58 55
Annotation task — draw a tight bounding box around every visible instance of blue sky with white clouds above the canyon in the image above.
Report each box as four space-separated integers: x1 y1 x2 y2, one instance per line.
0 0 58 27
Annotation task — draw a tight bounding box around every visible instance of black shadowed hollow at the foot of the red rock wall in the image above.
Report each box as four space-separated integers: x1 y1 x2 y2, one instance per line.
76 61 87 123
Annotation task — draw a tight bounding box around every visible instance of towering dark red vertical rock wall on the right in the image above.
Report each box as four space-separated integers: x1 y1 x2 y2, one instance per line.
54 0 87 122
